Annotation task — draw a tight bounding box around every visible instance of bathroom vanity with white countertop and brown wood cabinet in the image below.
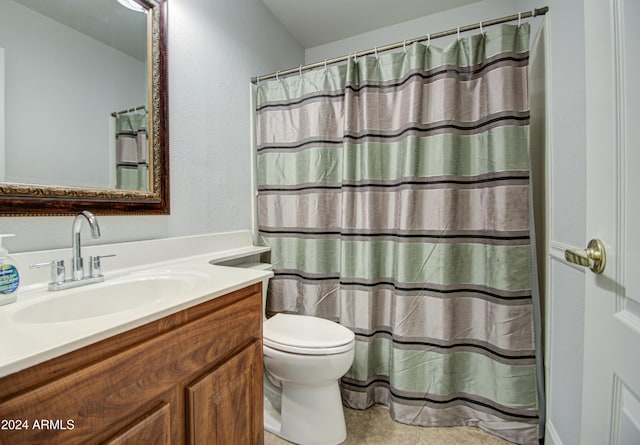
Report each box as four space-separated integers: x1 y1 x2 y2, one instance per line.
0 231 265 445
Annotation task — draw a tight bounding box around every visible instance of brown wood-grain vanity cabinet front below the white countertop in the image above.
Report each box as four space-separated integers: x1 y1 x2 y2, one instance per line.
0 284 263 445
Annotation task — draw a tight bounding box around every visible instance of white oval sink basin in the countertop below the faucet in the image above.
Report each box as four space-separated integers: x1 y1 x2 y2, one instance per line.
12 271 204 324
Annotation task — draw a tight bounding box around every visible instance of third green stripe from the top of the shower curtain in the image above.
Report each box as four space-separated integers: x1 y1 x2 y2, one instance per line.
269 238 531 290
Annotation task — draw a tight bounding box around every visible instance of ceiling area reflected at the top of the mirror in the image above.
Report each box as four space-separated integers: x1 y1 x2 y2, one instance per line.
15 0 147 62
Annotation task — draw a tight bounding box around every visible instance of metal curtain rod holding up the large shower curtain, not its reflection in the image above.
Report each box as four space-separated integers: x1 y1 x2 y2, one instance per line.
251 6 549 83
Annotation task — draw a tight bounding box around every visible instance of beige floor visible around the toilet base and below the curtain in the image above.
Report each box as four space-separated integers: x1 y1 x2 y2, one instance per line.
264 405 510 445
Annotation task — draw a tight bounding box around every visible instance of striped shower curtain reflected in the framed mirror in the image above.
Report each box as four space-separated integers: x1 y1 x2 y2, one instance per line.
116 113 149 191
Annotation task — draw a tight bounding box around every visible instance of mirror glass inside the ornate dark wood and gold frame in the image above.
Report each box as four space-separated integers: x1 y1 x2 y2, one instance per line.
0 0 149 190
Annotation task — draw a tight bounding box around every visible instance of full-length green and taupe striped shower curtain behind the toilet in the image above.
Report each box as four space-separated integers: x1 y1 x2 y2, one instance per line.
256 24 541 444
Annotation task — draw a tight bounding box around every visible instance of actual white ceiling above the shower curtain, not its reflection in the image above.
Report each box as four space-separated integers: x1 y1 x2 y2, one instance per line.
262 0 480 48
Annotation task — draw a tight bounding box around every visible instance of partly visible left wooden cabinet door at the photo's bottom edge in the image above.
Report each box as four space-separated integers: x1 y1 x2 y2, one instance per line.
105 403 171 445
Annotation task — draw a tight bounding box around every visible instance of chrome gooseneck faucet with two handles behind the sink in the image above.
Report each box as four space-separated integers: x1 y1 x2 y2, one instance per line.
30 210 115 290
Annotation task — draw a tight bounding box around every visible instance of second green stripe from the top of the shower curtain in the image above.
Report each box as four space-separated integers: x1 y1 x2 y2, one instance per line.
258 126 529 185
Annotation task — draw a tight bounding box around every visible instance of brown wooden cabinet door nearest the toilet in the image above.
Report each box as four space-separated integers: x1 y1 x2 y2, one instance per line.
187 340 264 445
